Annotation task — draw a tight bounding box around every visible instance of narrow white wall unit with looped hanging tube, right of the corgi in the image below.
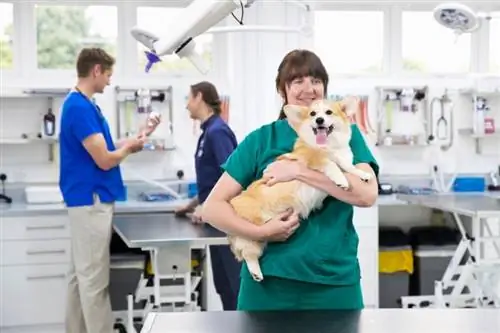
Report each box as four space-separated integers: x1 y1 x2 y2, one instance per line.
429 90 455 151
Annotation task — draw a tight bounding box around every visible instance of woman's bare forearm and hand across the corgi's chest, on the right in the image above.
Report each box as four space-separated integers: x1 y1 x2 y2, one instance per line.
292 162 378 207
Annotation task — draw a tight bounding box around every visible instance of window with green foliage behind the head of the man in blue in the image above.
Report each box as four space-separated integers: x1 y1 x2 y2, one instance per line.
35 5 118 69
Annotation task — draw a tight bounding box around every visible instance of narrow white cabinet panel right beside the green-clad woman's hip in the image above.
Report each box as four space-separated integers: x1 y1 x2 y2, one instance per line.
354 205 378 308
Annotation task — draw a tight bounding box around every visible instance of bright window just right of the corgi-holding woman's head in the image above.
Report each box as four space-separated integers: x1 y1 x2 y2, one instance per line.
314 11 384 74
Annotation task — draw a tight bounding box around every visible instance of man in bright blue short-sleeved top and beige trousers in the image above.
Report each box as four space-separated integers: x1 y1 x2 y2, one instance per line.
59 48 159 333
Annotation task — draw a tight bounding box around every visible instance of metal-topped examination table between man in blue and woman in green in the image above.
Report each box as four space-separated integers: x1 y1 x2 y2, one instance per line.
113 212 227 333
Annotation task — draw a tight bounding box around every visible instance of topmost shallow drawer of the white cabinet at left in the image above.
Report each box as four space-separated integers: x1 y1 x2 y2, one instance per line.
0 215 69 240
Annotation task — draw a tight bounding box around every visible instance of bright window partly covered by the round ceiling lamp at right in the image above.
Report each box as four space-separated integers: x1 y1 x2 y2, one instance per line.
402 11 471 74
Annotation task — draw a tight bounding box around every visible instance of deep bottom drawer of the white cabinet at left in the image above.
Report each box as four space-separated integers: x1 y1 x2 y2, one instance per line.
0 265 68 327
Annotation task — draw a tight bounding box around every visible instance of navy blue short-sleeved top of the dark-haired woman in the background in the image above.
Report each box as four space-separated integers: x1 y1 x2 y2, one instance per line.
195 115 238 204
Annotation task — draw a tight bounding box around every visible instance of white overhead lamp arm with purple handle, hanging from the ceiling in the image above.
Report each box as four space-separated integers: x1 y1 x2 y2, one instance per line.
131 0 311 74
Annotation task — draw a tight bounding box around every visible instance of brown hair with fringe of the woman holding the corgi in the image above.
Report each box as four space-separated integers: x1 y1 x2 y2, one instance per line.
276 50 328 119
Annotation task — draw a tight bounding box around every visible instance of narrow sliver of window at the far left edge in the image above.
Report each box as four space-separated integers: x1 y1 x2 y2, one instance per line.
0 2 14 69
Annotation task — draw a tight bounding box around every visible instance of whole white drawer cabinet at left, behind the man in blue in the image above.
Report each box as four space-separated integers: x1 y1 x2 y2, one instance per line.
0 215 71 333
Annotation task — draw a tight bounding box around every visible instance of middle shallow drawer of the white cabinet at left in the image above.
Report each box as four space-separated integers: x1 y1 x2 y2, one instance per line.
0 239 71 266
